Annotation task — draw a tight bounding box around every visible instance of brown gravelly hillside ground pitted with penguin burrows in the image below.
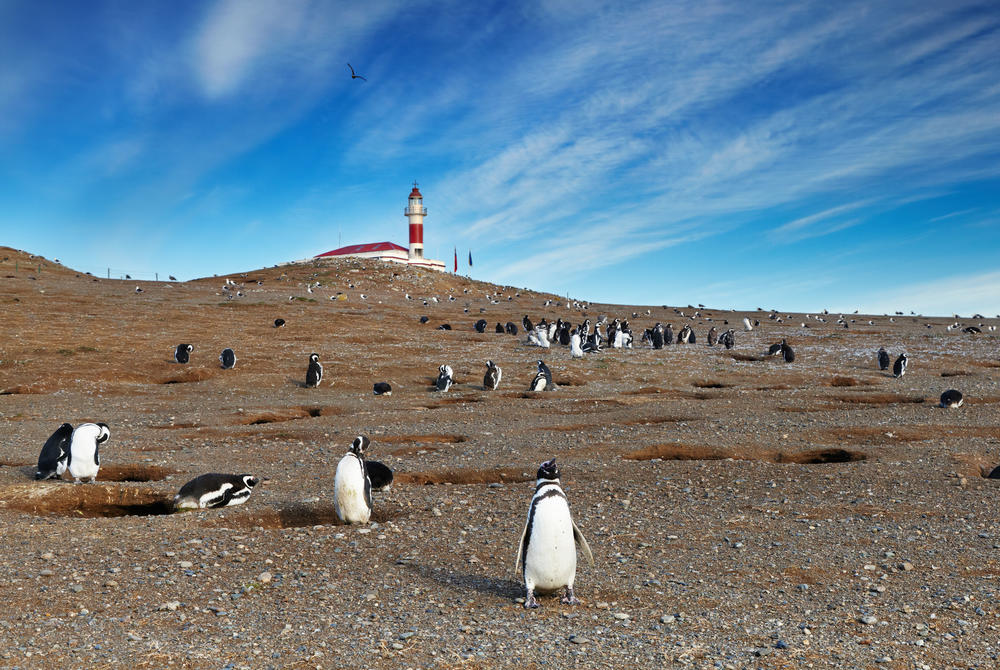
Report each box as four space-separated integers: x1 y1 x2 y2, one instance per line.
0 249 1000 669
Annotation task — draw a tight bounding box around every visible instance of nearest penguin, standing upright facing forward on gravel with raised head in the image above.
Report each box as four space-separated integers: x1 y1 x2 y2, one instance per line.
514 458 594 608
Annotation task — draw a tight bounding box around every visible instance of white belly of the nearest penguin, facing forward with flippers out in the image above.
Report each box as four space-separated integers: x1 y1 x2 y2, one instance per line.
524 504 576 593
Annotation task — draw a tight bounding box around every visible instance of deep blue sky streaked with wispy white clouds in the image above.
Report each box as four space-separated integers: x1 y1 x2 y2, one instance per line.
0 0 1000 316
